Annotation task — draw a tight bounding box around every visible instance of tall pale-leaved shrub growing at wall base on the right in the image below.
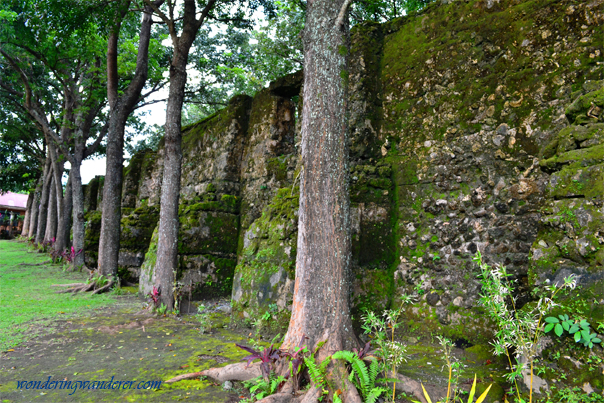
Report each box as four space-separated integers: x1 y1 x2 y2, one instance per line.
473 251 577 403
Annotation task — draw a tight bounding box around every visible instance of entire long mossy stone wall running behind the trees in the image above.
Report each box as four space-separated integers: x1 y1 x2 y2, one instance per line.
82 0 604 342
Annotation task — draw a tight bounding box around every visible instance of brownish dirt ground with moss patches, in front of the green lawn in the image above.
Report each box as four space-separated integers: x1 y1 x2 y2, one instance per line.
0 296 260 402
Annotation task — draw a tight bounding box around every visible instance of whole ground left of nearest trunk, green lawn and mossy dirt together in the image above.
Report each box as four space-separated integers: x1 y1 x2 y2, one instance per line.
0 241 258 402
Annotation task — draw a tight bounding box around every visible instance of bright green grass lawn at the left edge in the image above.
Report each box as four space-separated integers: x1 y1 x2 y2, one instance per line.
0 241 116 351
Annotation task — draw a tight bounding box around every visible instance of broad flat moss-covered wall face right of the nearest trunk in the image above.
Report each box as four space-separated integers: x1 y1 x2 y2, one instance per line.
378 0 603 344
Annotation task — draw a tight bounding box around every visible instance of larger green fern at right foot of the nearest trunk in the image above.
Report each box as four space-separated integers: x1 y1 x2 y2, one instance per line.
332 351 389 403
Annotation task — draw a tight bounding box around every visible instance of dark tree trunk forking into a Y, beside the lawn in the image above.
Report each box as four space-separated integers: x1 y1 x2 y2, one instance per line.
98 2 162 276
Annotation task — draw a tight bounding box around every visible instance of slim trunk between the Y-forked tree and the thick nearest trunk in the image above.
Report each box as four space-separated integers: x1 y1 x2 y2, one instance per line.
155 55 188 309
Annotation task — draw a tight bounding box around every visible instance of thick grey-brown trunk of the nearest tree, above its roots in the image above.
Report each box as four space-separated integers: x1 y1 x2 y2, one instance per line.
283 0 358 358
